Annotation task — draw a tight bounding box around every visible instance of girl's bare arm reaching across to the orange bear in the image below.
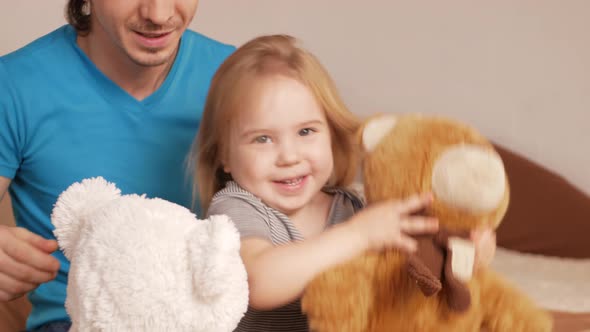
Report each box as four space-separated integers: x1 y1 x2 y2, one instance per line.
241 196 437 310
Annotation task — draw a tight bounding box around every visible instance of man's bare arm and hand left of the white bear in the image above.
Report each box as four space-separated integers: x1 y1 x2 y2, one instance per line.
0 176 59 301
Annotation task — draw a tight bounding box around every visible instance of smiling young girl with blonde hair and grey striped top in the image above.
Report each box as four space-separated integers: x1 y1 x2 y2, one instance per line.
192 35 495 332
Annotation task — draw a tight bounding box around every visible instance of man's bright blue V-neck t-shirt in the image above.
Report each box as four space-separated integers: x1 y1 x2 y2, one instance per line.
0 25 234 328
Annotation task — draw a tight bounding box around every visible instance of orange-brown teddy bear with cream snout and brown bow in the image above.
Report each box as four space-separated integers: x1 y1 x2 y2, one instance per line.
302 115 552 332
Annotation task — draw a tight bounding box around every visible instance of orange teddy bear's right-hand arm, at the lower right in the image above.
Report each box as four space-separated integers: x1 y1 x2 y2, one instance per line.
478 270 553 332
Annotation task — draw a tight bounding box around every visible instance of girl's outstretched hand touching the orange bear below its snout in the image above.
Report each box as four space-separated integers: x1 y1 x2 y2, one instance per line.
351 194 438 252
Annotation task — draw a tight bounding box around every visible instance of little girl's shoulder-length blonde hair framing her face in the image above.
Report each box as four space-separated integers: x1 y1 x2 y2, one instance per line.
189 35 359 213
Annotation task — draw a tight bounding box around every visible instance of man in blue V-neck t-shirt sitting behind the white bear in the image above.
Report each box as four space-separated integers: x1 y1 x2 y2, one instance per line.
0 0 234 331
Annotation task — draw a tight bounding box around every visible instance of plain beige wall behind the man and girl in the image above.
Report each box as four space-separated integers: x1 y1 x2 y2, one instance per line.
0 0 590 193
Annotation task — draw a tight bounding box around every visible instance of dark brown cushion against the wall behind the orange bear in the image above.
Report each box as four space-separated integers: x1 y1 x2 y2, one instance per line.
496 145 590 258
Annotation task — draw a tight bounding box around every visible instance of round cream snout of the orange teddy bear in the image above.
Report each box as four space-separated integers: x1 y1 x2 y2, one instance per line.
432 144 506 213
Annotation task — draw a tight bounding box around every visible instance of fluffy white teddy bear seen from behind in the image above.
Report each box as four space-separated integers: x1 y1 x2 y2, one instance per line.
52 177 248 332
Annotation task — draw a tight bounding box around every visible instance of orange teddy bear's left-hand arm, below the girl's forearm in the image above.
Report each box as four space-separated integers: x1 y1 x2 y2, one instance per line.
301 257 375 332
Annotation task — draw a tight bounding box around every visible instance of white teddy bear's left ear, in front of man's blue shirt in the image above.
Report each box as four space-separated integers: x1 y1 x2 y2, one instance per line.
51 177 121 259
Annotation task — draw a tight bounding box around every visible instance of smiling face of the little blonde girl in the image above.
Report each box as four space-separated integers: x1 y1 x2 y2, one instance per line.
223 75 334 215
